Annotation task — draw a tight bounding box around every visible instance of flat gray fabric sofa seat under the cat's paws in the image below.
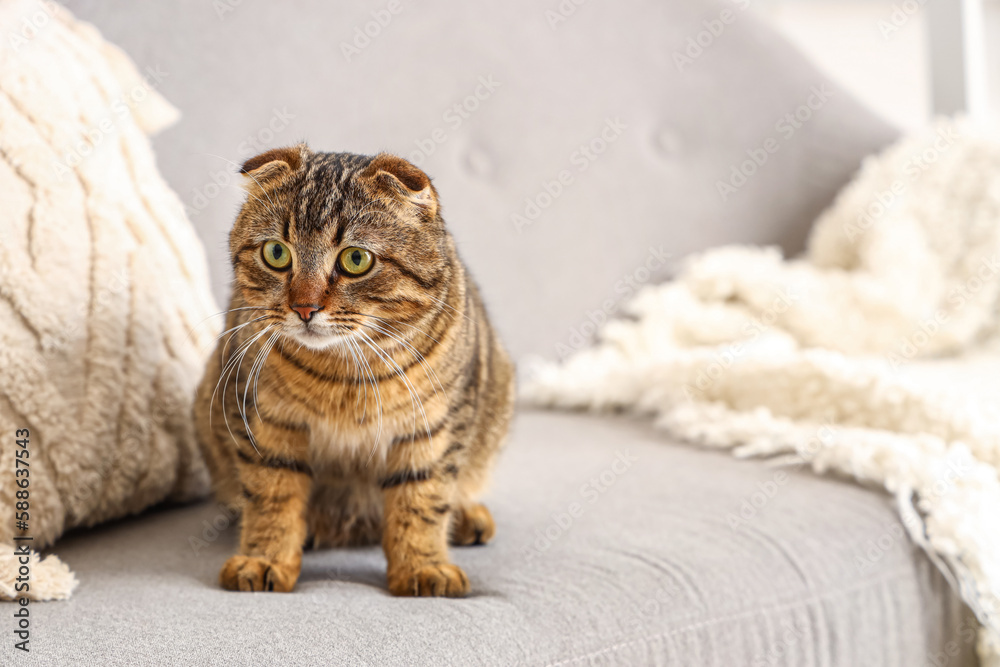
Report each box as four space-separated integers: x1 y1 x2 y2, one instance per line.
0 413 973 667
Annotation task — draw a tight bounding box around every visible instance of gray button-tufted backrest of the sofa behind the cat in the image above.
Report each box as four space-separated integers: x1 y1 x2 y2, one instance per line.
58 0 895 357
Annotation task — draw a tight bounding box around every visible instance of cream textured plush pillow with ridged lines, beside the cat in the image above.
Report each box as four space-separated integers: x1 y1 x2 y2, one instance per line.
0 1 218 597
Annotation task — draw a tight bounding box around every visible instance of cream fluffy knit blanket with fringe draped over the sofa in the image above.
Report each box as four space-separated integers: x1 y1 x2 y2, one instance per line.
522 121 1000 667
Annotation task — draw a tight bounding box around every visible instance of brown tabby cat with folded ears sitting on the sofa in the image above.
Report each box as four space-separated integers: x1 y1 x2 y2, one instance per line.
195 144 514 597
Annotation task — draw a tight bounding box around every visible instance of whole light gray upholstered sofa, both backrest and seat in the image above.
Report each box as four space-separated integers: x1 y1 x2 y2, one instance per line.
31 0 975 667
